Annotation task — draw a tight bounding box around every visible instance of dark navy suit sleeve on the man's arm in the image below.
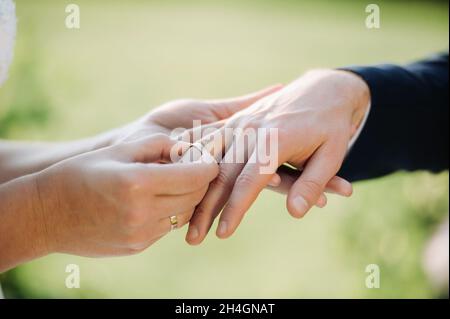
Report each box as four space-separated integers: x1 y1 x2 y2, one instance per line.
339 53 449 181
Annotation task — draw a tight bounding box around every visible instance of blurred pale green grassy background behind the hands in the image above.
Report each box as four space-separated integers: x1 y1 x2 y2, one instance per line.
0 0 449 298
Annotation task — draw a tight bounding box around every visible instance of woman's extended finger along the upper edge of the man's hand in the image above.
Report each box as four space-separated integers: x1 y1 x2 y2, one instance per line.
209 84 283 120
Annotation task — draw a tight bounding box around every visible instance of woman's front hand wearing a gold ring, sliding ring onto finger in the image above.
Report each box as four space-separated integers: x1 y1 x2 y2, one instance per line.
0 134 218 269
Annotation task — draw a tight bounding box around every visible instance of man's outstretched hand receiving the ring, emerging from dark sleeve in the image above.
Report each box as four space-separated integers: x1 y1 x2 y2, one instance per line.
186 70 369 244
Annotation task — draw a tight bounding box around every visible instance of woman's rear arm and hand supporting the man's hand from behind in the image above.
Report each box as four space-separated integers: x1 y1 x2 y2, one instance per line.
0 85 281 184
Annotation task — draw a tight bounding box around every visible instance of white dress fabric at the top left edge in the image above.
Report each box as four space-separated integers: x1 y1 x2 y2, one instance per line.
0 0 16 299
